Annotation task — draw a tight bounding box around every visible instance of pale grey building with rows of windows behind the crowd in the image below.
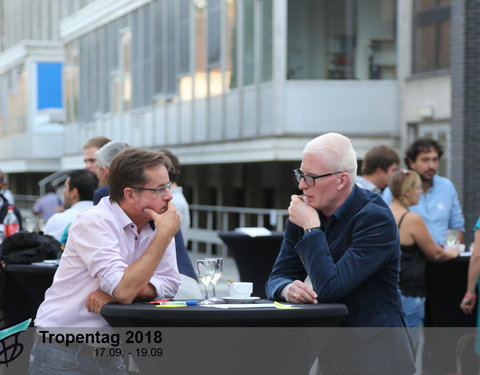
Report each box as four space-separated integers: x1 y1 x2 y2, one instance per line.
0 0 480 239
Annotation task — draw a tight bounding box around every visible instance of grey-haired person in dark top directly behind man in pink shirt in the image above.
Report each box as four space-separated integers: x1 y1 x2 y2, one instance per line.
93 141 129 205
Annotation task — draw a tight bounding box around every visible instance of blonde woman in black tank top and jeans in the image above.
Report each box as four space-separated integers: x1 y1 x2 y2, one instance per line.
390 169 459 346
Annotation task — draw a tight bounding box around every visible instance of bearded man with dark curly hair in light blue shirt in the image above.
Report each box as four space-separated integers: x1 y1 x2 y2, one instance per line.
383 138 465 245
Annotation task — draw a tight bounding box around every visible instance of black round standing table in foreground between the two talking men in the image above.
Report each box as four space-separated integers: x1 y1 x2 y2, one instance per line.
101 301 347 375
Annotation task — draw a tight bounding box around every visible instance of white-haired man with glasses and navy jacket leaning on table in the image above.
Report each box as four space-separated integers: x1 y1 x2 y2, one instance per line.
266 133 415 374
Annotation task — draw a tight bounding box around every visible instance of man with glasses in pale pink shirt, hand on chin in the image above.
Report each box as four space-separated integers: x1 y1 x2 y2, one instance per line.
30 148 180 375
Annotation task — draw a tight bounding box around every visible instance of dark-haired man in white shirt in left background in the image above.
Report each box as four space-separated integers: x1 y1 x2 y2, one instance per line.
44 169 98 241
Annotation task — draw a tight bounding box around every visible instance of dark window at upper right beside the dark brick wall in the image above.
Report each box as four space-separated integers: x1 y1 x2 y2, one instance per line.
412 0 451 74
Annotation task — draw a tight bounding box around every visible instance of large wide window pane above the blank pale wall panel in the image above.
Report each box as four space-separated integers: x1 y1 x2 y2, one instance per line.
287 0 396 79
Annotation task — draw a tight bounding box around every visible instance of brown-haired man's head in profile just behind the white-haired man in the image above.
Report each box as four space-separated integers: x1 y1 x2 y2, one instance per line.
356 145 400 194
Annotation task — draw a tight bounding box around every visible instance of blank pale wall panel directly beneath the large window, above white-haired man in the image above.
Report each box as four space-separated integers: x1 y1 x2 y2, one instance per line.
285 81 398 136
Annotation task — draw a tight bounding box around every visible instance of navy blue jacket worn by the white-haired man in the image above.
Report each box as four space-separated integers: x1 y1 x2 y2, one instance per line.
266 186 405 327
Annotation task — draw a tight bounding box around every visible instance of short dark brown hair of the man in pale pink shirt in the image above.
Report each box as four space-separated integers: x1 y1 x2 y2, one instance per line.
108 147 171 203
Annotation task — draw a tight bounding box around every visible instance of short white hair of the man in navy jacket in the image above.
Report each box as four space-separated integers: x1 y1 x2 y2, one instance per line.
303 133 357 186
